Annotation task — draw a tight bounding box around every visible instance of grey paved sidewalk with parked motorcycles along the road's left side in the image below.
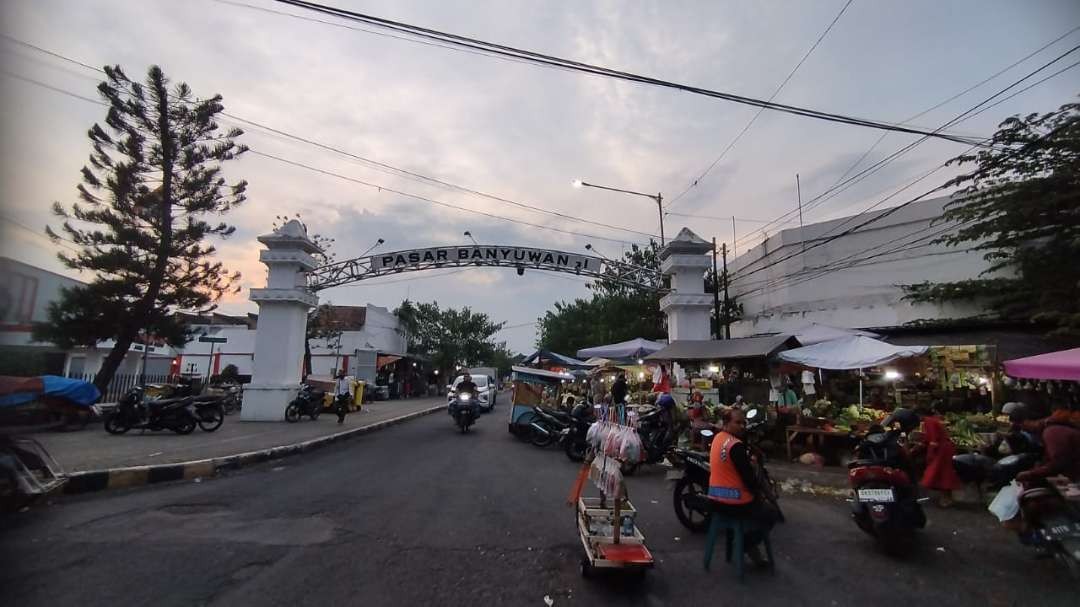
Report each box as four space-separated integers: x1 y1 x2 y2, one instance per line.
35 396 446 474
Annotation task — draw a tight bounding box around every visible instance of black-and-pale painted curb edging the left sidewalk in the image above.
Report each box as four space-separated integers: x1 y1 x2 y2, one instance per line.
64 404 446 495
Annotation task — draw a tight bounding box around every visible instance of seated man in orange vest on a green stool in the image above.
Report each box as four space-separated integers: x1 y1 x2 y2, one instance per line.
708 407 779 565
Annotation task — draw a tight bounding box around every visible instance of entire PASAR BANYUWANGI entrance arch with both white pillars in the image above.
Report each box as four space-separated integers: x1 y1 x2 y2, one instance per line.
241 220 713 421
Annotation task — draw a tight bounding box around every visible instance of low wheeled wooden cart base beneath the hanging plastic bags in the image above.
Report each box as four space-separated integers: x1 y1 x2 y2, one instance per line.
577 497 653 578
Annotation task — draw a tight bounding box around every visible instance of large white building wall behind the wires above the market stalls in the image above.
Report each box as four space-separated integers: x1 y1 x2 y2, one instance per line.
729 197 987 337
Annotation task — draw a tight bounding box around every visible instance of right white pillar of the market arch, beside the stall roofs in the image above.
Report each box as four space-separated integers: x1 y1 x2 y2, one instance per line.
660 228 713 343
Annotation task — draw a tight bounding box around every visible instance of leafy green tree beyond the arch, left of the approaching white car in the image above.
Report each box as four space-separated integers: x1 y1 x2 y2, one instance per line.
394 299 510 372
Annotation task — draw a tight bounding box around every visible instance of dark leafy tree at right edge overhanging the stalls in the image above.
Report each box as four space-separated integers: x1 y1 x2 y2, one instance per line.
905 99 1080 337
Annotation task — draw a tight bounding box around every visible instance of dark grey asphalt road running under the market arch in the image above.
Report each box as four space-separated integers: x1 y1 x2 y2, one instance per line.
0 406 1078 607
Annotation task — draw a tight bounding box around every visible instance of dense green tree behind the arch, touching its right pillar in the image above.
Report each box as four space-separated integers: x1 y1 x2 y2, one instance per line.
537 241 667 356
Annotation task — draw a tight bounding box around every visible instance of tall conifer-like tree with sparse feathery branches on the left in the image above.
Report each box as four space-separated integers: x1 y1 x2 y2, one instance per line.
33 66 247 392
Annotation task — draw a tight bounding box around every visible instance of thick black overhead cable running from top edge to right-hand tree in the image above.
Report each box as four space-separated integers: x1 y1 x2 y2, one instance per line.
267 0 980 145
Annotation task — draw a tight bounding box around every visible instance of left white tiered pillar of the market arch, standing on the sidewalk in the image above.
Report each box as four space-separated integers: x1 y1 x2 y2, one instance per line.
240 219 320 421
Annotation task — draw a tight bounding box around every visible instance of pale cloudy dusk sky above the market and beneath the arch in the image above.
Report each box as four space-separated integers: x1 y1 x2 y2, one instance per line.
0 0 1080 354
